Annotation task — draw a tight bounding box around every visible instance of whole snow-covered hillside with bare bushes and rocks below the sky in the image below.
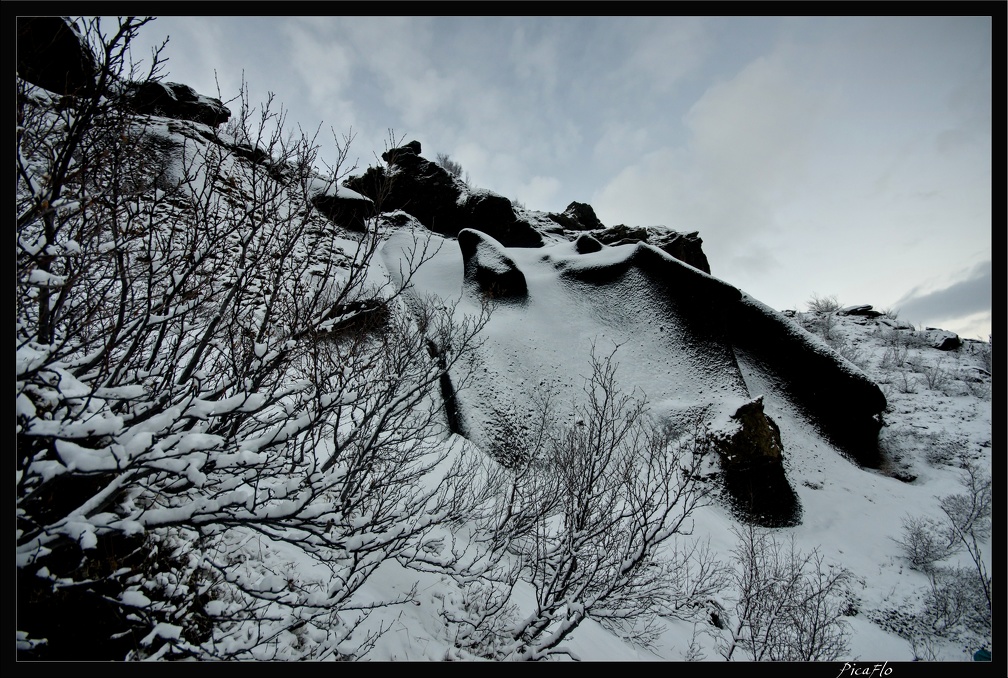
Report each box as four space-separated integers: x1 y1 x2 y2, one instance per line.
15 17 993 662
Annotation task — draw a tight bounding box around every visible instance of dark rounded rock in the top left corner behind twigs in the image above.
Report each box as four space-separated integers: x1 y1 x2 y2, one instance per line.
17 16 98 95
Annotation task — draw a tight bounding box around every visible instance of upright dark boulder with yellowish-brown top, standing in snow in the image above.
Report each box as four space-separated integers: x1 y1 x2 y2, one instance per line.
714 397 801 527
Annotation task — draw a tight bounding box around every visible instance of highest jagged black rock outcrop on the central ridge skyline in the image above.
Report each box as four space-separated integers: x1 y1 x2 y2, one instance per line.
344 141 542 247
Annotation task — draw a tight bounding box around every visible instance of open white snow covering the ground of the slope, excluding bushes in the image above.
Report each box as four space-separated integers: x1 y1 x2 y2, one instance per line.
362 221 993 661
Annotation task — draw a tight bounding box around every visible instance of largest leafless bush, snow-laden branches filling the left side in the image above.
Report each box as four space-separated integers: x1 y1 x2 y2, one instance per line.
16 19 487 659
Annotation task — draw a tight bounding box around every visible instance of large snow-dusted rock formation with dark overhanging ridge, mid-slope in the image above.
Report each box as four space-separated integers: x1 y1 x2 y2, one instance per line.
383 230 886 527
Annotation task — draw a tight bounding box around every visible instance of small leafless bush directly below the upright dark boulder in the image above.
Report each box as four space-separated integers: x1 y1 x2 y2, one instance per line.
721 525 851 662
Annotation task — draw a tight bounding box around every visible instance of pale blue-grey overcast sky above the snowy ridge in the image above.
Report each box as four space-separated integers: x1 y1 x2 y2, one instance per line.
123 14 991 338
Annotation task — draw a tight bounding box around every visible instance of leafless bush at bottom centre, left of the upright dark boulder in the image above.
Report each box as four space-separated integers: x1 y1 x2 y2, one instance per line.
429 344 724 660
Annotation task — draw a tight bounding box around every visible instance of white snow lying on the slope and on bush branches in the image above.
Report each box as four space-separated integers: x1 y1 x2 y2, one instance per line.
15 92 1001 662
